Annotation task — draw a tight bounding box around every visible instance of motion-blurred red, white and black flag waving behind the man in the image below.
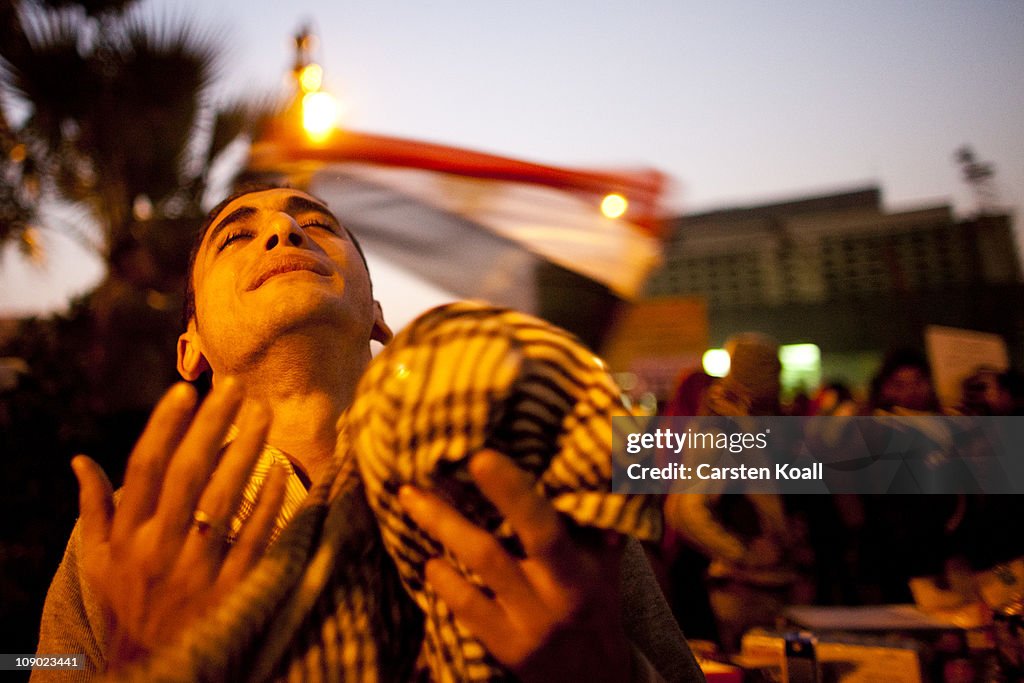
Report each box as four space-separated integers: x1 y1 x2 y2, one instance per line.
248 131 665 342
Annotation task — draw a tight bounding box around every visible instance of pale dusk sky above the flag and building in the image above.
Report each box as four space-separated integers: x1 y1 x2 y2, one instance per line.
0 0 1024 329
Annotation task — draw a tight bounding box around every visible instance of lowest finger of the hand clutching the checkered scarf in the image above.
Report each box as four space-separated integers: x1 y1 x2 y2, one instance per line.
425 559 514 660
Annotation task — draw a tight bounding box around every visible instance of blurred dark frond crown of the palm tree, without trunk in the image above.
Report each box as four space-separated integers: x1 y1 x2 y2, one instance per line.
0 0 266 266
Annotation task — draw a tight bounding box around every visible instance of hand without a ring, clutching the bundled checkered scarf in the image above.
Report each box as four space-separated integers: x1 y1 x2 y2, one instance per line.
399 451 631 681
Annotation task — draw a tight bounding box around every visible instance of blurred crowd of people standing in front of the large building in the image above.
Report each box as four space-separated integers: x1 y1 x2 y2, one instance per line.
649 333 1024 652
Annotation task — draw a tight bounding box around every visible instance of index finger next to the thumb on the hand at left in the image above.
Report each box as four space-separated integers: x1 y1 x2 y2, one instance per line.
112 382 197 538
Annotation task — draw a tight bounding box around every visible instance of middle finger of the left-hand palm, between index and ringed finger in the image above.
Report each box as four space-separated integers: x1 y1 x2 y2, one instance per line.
156 377 243 543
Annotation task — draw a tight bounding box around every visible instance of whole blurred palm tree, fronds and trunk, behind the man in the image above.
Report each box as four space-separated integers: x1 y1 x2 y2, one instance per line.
0 0 269 411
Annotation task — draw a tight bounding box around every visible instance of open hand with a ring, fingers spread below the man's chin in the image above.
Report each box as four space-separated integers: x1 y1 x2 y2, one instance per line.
72 378 286 669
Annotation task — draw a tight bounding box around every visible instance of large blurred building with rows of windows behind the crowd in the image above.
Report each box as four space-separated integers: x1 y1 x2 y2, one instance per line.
645 187 1024 395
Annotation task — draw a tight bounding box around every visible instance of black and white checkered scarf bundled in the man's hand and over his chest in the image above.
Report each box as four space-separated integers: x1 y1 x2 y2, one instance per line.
108 302 660 681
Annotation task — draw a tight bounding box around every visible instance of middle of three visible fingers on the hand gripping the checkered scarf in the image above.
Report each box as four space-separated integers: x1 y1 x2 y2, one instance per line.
398 486 532 601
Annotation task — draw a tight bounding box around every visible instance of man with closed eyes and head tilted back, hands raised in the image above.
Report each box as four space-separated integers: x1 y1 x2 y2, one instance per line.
36 187 700 681
